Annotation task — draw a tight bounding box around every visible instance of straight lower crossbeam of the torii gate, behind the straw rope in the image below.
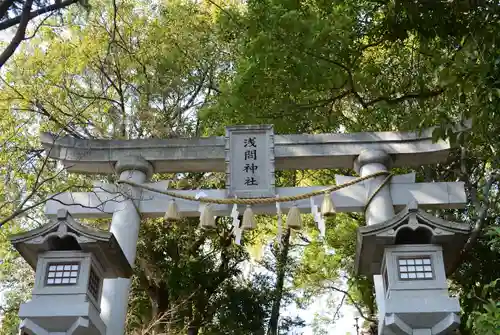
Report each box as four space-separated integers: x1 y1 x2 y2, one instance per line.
45 182 466 218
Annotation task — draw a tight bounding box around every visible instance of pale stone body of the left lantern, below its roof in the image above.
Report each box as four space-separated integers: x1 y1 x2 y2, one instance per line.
19 251 106 335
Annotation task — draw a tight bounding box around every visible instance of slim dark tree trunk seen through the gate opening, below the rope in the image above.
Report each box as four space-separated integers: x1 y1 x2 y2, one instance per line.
267 228 290 335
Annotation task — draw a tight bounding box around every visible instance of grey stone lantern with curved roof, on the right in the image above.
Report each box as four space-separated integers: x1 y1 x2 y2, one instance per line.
356 202 470 335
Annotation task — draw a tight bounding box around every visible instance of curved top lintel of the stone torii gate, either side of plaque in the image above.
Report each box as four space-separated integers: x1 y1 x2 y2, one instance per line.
41 124 464 174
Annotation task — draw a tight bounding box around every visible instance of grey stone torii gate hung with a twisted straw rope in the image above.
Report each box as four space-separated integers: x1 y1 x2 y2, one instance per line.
41 125 466 335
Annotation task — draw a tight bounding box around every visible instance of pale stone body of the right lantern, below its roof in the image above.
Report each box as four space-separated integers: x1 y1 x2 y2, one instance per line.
374 244 460 335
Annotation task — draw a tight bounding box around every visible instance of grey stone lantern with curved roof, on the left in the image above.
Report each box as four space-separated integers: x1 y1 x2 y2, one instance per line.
11 210 132 335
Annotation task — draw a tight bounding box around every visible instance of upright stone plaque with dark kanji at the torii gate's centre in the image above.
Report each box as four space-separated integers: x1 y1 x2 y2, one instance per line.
226 125 275 198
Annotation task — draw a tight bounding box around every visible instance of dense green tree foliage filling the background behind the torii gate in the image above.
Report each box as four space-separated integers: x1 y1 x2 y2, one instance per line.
0 0 500 335
